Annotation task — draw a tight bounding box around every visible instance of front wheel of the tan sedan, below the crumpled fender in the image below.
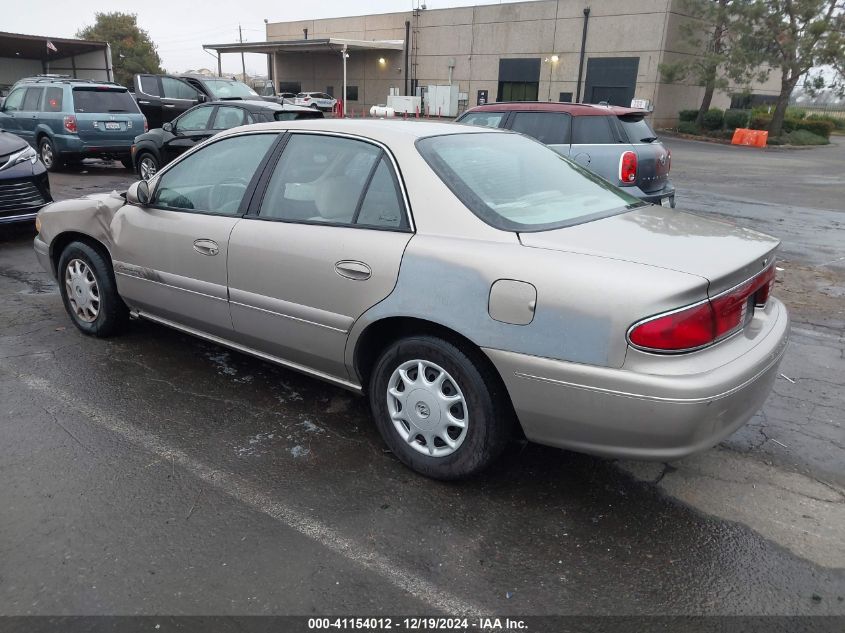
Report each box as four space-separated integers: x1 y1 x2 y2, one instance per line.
58 242 129 338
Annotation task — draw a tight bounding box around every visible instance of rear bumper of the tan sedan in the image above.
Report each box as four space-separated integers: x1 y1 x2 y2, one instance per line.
484 299 789 461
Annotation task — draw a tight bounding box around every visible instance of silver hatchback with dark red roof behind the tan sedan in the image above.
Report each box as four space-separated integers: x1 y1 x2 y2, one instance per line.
458 101 675 208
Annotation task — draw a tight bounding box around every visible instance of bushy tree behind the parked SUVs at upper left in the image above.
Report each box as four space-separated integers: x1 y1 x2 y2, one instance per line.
76 11 162 86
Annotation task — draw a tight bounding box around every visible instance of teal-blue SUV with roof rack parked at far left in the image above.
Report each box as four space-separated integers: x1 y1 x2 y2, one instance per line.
0 76 147 171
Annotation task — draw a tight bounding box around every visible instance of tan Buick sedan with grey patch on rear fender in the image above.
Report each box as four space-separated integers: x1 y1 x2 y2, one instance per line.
35 120 789 479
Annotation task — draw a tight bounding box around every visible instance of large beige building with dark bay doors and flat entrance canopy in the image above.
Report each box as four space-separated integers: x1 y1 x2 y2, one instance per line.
206 0 777 126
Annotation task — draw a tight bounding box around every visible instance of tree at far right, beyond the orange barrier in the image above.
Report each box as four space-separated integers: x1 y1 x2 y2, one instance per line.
736 0 845 136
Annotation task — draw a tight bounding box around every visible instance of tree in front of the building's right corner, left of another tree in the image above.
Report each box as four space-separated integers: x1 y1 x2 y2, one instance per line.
660 0 760 125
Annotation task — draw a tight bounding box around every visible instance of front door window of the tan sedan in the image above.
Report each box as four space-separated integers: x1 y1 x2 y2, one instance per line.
152 134 276 215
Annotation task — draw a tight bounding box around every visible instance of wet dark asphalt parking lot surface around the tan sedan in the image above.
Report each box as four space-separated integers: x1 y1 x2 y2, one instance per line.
0 146 845 615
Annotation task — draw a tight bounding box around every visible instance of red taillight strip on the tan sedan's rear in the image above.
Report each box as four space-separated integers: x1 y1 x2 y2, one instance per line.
628 264 775 352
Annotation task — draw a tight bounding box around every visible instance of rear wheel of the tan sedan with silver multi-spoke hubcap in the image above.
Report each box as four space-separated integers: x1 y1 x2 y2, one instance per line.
369 335 513 480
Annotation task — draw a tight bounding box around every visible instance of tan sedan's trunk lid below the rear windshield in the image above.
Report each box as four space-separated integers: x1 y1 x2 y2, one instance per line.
519 205 780 297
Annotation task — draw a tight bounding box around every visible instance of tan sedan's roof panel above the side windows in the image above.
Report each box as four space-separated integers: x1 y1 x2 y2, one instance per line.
218 118 502 145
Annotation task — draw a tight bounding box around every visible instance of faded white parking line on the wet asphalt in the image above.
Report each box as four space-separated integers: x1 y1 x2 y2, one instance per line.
9 369 488 616
